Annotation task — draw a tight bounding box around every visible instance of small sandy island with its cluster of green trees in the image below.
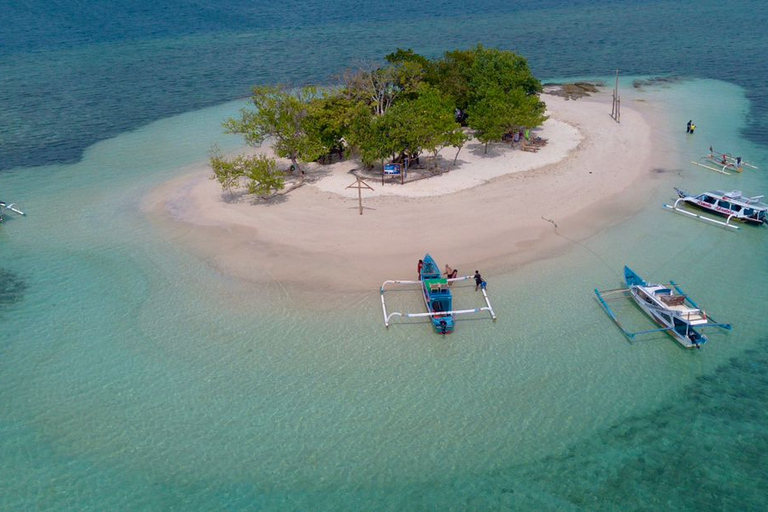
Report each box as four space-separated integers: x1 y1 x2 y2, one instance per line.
147 46 674 308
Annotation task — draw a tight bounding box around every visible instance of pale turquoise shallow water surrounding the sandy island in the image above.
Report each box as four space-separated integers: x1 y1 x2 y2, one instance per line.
0 76 768 510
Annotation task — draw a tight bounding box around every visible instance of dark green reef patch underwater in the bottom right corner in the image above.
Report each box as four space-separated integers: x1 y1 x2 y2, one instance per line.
504 340 768 511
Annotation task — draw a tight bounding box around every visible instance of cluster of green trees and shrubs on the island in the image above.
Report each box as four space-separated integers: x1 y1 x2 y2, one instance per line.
211 45 546 197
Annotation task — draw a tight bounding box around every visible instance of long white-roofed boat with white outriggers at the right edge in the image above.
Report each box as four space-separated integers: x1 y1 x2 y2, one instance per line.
664 188 768 229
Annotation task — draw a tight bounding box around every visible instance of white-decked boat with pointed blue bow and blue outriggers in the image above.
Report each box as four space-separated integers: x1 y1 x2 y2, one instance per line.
595 266 731 348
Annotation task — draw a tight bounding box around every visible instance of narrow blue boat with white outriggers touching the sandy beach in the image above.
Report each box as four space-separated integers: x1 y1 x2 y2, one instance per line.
380 254 496 335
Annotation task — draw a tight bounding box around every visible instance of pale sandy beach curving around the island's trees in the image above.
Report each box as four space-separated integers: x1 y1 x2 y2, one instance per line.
145 92 673 299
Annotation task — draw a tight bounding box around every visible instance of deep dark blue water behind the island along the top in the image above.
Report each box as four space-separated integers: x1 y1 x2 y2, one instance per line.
0 0 768 170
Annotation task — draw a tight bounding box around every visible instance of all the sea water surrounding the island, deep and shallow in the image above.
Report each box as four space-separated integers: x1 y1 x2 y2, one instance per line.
0 0 768 511
